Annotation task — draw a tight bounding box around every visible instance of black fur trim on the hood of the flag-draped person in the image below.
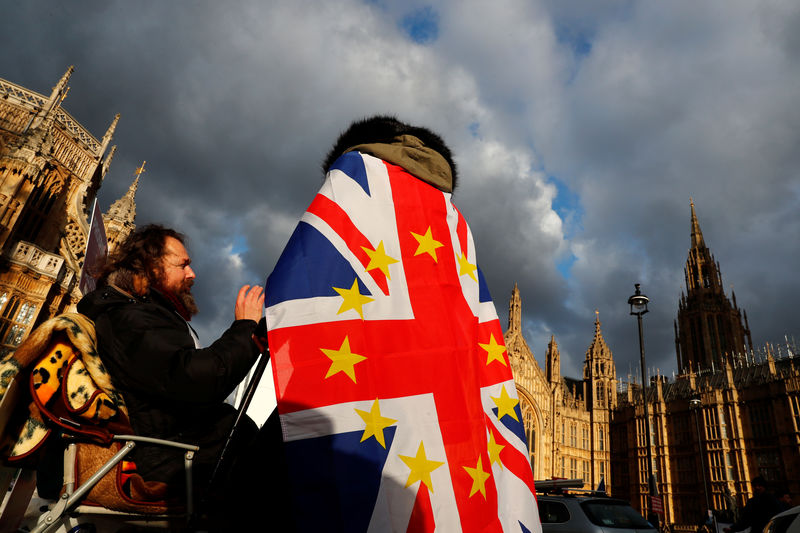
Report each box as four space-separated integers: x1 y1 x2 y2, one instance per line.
322 115 458 190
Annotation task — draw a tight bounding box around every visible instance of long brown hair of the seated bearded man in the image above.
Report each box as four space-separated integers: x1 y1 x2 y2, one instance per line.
99 224 185 292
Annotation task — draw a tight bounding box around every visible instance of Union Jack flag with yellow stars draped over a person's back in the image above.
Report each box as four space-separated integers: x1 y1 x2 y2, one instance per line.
266 152 541 532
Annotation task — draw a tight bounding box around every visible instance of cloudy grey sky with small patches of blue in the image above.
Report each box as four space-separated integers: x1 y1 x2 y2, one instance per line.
0 0 800 378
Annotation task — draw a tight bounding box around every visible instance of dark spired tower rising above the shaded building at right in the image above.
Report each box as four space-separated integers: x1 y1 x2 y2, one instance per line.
674 199 753 372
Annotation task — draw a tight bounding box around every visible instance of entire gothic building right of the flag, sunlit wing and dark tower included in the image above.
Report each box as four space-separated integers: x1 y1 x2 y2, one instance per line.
506 204 800 531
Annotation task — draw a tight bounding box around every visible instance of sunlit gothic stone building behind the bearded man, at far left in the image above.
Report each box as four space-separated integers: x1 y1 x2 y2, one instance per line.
0 67 137 357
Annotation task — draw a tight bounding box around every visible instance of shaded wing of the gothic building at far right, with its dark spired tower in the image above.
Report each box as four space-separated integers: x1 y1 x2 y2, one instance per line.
611 203 800 525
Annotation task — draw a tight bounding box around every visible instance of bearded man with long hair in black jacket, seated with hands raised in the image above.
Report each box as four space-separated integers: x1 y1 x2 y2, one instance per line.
78 225 264 495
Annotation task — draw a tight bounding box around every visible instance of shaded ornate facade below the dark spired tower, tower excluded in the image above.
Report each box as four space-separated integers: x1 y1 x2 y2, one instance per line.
611 354 800 525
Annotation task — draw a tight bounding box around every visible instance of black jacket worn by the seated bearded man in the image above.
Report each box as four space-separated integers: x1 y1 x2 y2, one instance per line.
78 286 258 490
